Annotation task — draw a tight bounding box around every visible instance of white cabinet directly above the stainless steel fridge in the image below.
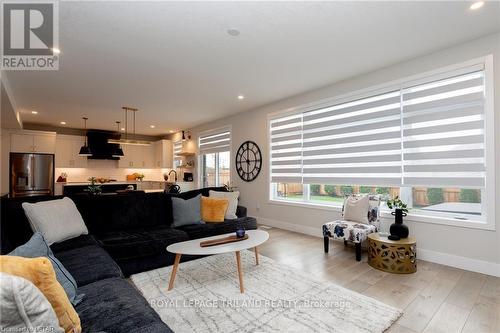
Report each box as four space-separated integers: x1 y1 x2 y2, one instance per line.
10 131 56 154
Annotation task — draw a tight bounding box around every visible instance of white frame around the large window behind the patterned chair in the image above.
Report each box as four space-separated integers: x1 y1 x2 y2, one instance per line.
267 54 496 230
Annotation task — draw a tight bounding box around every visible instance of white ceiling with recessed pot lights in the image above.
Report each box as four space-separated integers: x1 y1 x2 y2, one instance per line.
4 2 500 135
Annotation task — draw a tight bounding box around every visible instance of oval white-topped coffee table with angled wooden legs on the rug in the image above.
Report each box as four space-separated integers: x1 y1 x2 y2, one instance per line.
167 230 269 293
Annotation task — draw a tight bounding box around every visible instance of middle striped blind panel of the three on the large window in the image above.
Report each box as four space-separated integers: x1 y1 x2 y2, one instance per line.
302 91 401 185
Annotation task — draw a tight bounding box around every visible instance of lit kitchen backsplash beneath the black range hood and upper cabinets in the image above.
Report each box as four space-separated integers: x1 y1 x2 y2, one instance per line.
55 160 173 182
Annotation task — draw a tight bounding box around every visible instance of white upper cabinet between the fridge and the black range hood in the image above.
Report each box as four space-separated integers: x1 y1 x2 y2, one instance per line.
55 135 87 168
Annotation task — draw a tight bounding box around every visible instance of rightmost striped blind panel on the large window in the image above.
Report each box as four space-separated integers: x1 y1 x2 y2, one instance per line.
402 70 486 188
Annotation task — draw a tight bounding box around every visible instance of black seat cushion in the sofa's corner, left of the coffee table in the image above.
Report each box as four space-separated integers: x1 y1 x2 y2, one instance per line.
98 226 189 261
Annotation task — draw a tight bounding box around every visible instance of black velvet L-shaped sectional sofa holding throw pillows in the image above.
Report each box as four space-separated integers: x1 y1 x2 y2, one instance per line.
0 188 257 333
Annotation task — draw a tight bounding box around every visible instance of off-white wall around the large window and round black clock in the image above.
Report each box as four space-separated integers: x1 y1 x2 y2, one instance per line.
192 33 500 276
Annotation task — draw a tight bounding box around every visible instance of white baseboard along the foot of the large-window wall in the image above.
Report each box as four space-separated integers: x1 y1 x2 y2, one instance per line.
257 217 500 277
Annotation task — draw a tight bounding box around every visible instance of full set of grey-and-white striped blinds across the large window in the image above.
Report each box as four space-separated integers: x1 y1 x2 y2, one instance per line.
270 66 486 188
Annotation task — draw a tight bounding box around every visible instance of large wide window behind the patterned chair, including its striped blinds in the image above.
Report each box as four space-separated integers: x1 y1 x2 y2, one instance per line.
269 58 494 227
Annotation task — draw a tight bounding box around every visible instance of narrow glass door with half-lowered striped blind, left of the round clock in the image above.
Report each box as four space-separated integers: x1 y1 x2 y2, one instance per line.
198 128 231 187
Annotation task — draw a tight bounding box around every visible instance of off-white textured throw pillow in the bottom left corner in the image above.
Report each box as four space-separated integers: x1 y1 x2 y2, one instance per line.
0 273 64 333
